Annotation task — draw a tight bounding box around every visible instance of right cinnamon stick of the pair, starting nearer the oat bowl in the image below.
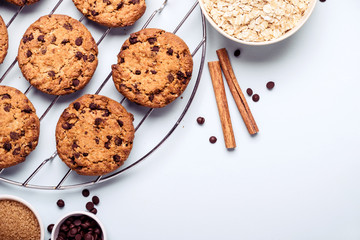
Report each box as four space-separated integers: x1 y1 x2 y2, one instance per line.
216 48 259 135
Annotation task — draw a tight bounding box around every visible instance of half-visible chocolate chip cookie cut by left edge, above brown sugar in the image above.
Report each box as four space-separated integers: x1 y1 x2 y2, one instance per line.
0 86 40 169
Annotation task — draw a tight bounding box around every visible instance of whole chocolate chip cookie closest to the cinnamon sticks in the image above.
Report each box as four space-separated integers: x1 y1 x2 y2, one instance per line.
112 29 193 108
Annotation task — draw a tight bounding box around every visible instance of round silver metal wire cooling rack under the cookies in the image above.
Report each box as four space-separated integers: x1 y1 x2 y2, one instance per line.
0 0 206 190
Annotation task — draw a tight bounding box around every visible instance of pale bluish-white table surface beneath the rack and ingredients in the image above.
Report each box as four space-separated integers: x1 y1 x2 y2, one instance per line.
0 0 360 240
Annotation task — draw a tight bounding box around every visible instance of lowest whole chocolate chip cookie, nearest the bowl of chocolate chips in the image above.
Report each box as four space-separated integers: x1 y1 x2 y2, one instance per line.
56 94 135 176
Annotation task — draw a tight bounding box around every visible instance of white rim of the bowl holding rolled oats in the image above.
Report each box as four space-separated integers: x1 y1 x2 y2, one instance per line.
199 0 317 46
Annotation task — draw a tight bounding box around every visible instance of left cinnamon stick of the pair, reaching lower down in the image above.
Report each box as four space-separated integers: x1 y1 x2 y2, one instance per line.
208 61 236 149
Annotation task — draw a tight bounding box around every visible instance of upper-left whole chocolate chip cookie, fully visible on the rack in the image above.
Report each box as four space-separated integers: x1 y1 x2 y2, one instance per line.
18 15 98 95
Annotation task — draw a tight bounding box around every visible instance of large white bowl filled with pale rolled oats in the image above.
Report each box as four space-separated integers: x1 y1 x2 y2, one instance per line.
199 0 316 45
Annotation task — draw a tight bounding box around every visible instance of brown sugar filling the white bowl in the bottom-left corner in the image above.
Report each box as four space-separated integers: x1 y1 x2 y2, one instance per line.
0 200 40 240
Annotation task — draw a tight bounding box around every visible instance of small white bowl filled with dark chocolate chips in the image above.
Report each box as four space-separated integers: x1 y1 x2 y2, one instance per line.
51 211 107 240
